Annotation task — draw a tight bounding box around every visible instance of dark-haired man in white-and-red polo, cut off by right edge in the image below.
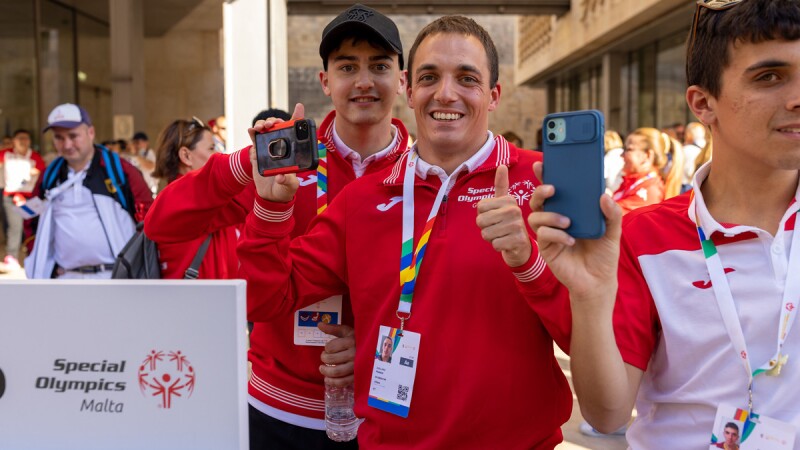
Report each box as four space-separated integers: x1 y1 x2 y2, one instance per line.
530 0 800 450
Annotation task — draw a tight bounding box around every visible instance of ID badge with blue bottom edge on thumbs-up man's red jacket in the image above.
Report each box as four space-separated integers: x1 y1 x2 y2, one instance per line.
367 326 420 418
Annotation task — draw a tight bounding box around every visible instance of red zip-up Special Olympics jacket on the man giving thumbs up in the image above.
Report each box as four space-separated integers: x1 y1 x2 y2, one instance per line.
238 137 572 449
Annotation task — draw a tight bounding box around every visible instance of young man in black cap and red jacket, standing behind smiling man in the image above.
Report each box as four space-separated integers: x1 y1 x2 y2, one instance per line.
145 5 408 449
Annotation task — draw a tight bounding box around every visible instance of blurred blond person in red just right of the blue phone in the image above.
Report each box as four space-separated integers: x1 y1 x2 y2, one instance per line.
613 128 669 214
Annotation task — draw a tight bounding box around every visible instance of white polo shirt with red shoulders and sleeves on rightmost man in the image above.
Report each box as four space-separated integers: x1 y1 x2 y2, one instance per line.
614 164 800 450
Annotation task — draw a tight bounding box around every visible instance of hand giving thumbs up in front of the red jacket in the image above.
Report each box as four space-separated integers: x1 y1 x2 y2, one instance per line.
476 166 532 267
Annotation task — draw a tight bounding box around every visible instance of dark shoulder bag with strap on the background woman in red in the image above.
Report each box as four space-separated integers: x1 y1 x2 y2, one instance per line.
111 222 211 280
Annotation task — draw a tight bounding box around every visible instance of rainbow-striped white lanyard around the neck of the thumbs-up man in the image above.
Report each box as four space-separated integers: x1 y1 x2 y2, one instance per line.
397 149 455 331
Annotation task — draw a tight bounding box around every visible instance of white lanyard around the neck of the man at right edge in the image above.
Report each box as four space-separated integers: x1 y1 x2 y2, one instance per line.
689 190 800 411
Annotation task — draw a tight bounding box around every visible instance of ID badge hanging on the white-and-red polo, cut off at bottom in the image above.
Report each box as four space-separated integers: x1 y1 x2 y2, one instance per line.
708 405 795 450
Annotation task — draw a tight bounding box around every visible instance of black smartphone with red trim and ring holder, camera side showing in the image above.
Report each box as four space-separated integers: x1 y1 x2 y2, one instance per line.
256 119 319 177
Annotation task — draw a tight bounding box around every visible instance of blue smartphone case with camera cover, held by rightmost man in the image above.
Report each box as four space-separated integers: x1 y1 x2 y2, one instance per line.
542 110 606 239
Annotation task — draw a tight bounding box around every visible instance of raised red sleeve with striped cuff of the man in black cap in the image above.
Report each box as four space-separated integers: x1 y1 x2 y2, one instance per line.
144 147 255 243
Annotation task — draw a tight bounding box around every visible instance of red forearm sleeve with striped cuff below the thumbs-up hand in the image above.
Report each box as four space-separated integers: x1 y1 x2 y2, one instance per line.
511 235 572 353
